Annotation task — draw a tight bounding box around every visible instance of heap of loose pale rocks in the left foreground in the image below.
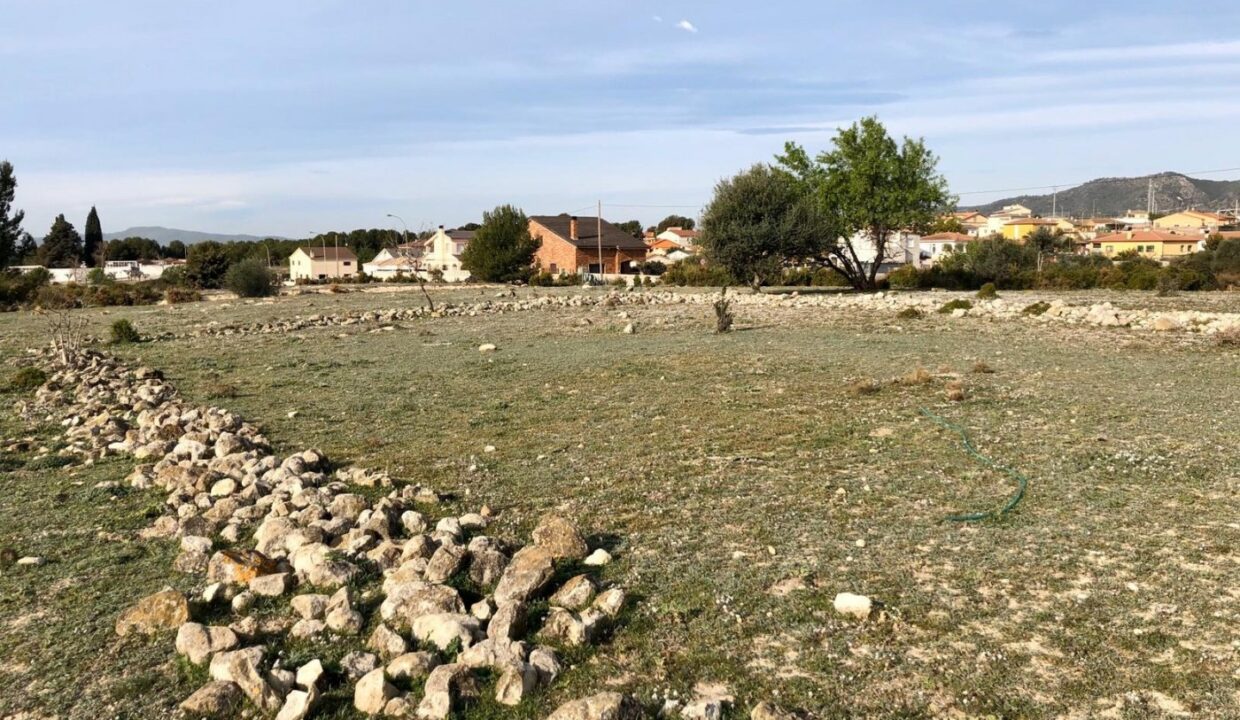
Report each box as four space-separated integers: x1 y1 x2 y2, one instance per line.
26 352 631 720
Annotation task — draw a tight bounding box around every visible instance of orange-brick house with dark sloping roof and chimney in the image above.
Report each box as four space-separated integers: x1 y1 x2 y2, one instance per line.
529 213 646 275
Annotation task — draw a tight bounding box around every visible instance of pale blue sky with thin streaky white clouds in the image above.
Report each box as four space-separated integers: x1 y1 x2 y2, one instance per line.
7 0 1240 237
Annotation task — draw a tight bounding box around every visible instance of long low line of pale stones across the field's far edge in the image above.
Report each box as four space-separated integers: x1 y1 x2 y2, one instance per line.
167 291 1240 337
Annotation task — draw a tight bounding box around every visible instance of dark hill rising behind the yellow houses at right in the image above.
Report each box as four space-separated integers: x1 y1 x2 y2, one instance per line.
961 172 1240 217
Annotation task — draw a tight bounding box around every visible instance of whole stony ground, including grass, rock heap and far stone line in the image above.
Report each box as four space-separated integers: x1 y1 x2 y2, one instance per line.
0 290 1240 720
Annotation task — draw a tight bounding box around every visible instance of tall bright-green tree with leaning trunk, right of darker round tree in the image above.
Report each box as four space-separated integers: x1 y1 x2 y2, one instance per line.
777 118 954 290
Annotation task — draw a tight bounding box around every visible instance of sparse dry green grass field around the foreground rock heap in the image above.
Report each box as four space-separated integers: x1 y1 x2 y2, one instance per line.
0 283 1240 719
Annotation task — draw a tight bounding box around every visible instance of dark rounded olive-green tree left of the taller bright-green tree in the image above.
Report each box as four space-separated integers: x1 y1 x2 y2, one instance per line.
699 165 822 291
